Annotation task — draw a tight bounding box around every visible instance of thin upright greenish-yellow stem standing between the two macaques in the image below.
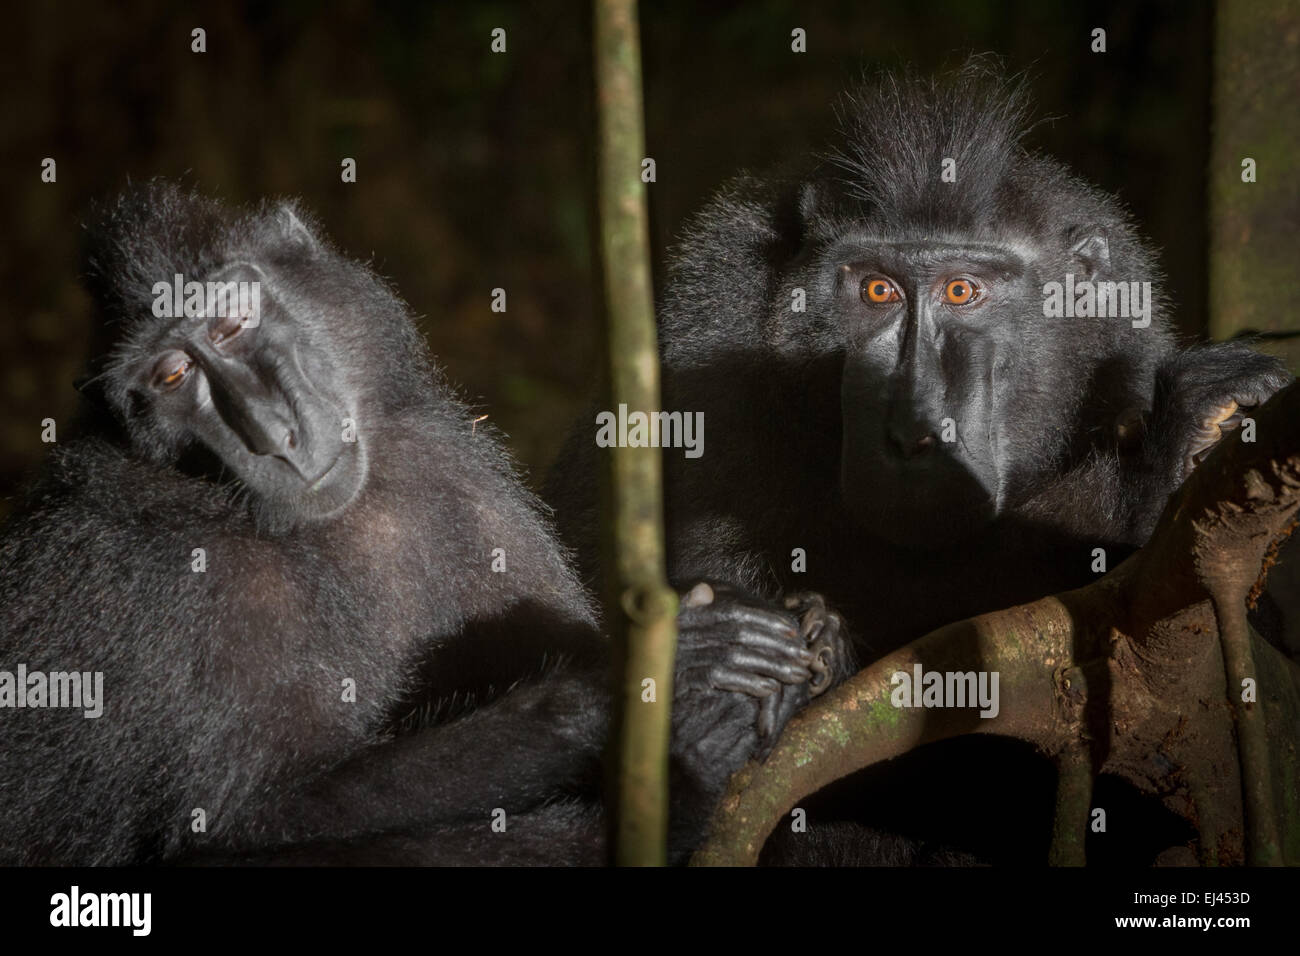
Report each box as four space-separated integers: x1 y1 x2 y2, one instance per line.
595 0 677 866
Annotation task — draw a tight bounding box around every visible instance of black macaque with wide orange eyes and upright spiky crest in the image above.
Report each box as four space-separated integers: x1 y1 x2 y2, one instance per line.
547 59 1290 862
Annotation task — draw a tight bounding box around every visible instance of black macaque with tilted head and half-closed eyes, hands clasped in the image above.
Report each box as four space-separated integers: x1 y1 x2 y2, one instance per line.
0 182 842 864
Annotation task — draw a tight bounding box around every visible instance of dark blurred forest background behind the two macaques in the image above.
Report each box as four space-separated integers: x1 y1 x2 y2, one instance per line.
0 0 1213 514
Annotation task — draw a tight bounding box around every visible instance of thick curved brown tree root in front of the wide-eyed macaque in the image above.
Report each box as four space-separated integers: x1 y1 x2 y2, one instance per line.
694 385 1300 865
